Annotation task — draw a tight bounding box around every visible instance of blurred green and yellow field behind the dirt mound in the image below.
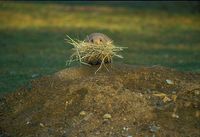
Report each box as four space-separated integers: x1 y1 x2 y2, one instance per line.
0 2 200 93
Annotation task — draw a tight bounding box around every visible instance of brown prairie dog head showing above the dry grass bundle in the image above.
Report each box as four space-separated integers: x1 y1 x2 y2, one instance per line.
85 33 112 44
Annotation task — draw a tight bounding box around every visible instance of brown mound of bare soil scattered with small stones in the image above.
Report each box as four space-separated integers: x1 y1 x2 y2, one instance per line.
0 65 200 137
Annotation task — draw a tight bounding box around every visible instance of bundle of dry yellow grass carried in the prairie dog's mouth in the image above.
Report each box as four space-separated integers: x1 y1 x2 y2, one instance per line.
66 35 126 73
